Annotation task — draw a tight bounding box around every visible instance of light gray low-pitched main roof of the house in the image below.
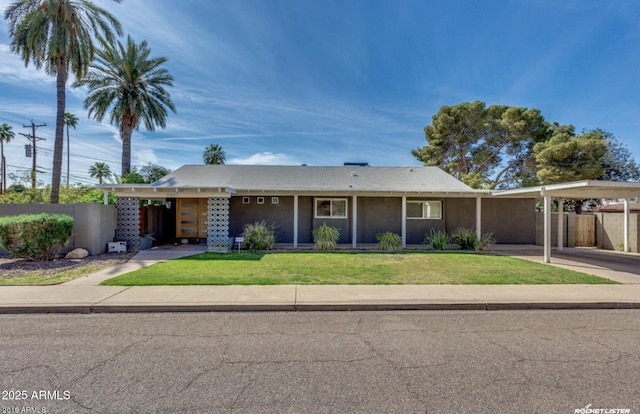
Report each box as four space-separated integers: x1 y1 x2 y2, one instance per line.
98 165 480 195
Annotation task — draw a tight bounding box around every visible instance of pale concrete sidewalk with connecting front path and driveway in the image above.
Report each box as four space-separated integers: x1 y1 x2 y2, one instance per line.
0 246 640 313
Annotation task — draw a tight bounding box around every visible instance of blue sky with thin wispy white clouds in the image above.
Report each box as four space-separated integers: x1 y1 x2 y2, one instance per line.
0 0 640 183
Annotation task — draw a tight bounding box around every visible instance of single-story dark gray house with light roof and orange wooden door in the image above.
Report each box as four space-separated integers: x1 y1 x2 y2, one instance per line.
98 165 535 251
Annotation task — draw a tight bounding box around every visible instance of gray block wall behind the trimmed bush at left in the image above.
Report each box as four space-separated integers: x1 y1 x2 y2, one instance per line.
0 203 116 255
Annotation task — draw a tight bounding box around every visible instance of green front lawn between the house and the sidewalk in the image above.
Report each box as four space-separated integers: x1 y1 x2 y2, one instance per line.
102 252 616 286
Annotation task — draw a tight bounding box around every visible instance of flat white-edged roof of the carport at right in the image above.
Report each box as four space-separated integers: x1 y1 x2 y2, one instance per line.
491 180 640 199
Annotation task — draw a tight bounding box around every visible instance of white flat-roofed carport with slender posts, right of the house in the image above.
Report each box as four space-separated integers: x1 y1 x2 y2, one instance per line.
492 180 640 263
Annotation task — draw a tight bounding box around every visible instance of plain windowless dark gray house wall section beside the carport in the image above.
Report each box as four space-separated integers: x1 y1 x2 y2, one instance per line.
482 198 536 244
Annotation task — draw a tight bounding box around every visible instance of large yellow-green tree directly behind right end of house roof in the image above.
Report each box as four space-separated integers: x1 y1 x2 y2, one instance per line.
412 101 549 188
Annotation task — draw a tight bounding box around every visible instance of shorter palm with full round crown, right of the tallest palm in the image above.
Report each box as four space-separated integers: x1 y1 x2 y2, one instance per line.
73 36 176 176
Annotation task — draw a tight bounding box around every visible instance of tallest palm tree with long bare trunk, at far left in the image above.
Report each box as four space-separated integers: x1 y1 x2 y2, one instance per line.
4 0 122 203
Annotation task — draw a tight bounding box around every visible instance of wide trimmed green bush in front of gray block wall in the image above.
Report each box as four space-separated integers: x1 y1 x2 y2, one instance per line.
0 213 73 260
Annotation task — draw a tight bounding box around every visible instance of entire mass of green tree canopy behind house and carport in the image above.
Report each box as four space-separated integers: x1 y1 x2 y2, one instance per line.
412 101 640 189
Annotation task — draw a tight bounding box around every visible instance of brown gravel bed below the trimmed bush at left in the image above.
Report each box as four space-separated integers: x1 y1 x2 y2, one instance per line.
0 253 135 278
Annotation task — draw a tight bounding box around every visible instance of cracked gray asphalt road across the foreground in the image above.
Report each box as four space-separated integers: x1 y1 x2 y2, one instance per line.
0 310 640 414
